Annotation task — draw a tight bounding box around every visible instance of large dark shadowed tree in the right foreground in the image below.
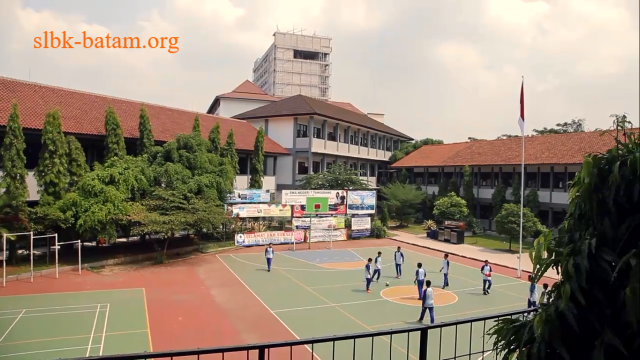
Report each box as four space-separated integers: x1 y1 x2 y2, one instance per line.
488 114 640 360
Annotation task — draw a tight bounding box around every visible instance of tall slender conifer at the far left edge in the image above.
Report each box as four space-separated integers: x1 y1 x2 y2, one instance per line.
0 103 29 211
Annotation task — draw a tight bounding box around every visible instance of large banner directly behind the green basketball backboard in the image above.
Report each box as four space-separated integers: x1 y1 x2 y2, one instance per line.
282 190 347 217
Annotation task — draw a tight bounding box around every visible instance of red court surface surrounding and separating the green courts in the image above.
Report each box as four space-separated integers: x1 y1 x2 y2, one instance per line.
0 239 554 359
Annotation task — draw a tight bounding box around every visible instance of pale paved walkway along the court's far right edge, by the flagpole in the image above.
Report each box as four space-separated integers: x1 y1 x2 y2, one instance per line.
391 230 558 279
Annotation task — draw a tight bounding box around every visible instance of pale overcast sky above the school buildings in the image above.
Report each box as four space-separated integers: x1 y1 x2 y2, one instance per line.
0 0 640 142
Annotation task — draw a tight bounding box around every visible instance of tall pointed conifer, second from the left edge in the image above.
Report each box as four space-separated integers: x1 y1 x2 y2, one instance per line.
35 110 69 200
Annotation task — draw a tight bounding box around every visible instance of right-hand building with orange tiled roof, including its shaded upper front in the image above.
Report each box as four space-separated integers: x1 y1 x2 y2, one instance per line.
391 131 636 230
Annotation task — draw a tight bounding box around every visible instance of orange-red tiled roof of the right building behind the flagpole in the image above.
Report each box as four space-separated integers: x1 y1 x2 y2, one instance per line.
391 128 638 168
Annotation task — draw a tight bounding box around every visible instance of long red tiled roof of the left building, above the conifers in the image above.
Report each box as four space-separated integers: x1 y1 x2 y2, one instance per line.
0 77 289 155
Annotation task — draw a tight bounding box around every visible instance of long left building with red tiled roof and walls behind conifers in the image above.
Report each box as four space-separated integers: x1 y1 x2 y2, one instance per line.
0 77 290 201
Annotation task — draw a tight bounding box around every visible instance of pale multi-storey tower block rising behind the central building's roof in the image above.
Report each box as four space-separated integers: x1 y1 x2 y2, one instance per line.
253 31 331 100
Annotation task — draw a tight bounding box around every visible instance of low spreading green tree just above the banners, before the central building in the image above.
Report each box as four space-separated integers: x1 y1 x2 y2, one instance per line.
298 164 369 190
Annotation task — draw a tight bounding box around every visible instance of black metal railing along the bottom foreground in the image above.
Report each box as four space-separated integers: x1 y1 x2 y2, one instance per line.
78 309 537 360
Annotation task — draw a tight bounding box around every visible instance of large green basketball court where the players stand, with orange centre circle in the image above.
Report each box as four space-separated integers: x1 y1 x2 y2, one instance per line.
218 247 540 360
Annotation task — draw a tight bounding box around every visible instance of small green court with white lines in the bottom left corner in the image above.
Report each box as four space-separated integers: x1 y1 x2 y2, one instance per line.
0 289 151 360
